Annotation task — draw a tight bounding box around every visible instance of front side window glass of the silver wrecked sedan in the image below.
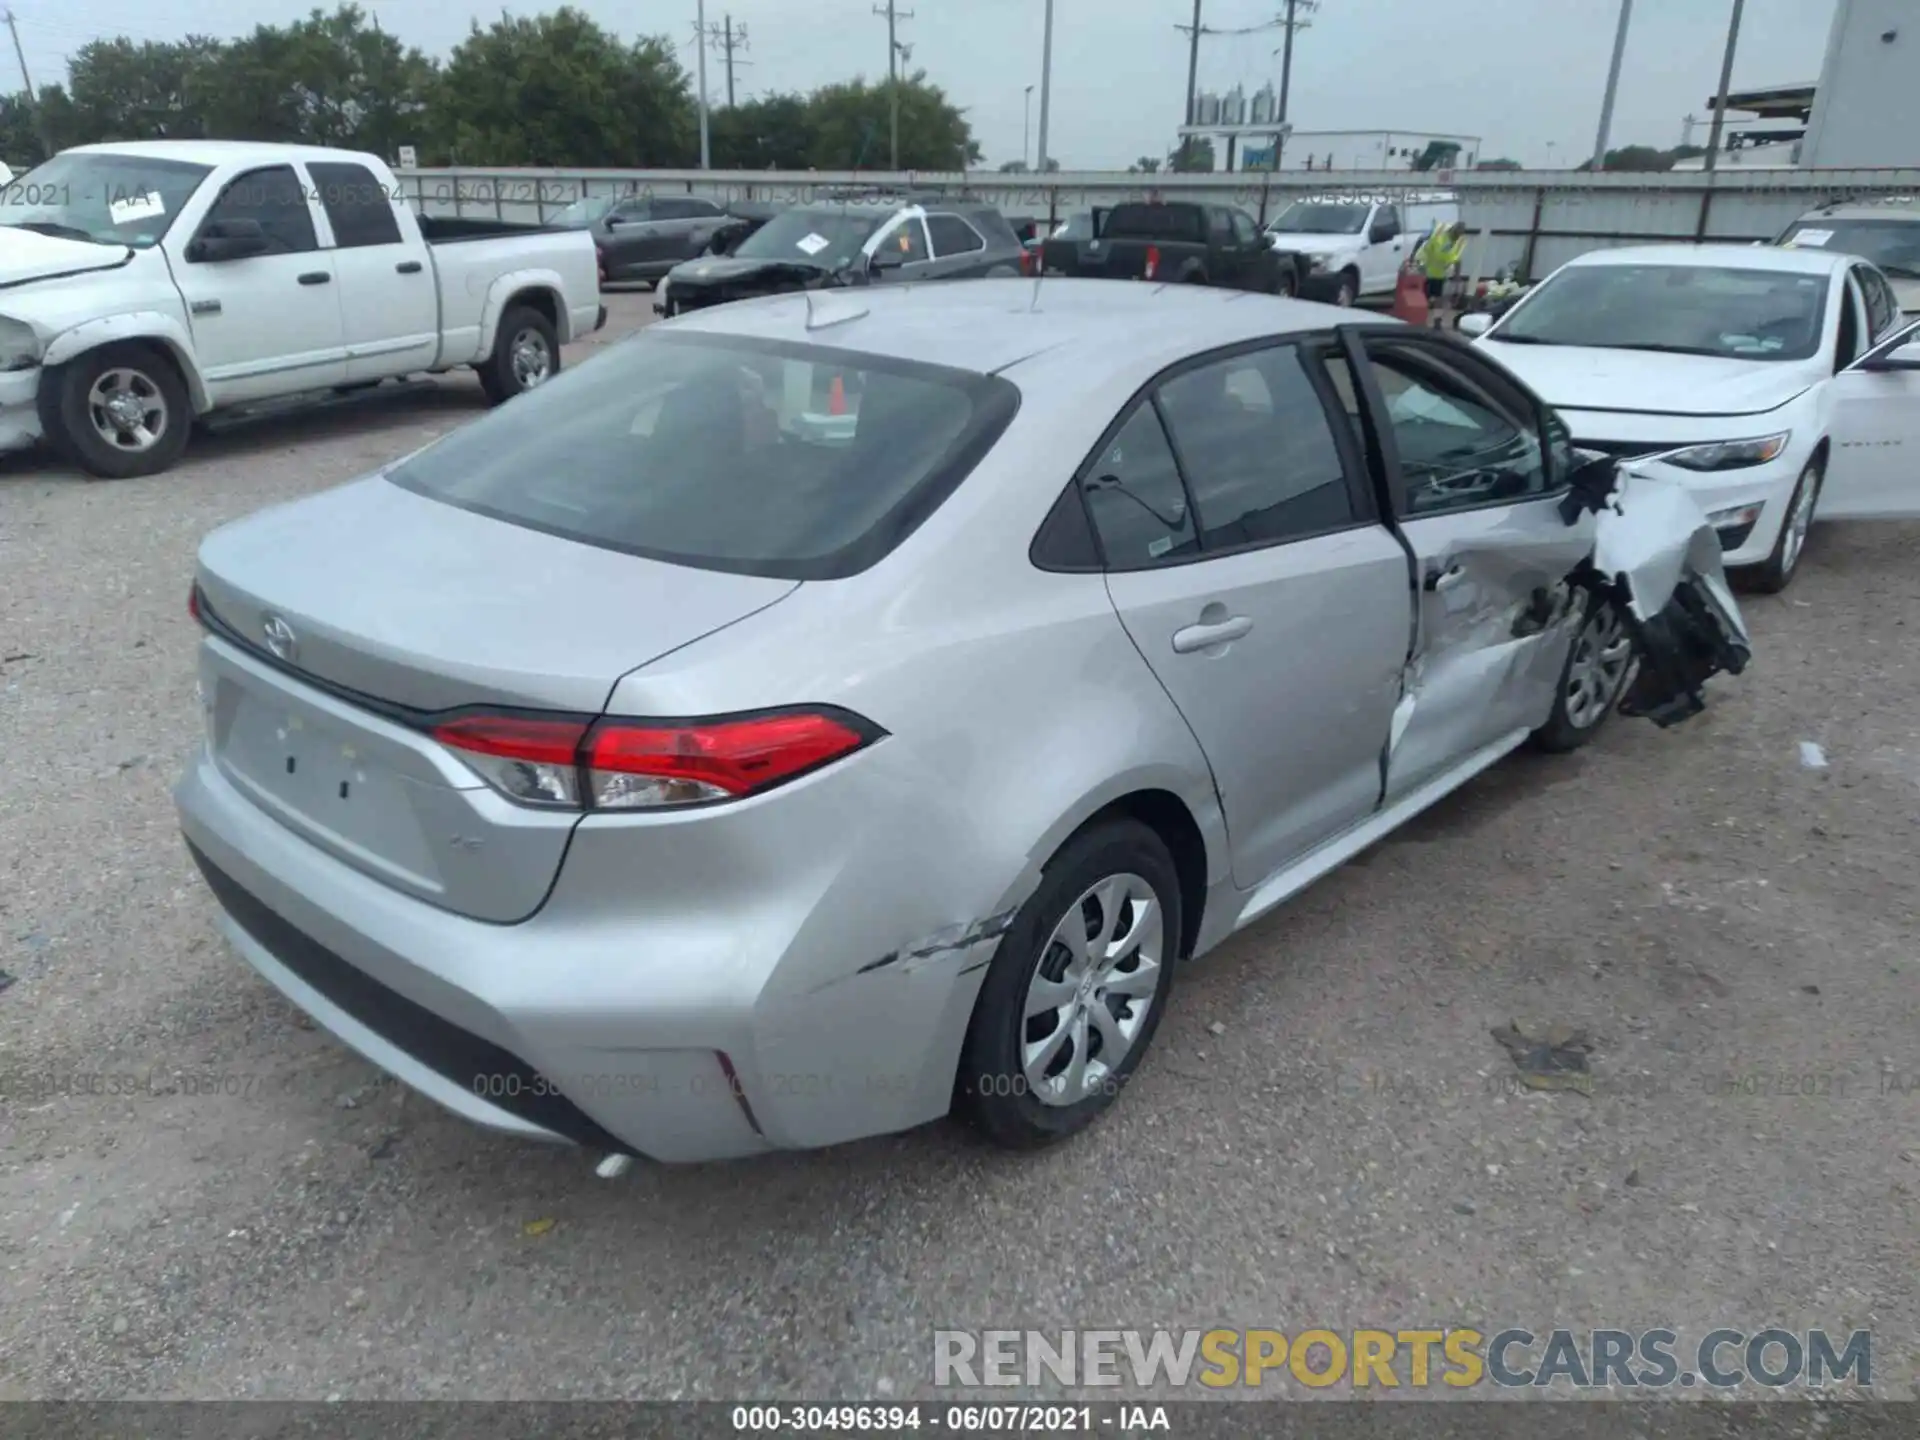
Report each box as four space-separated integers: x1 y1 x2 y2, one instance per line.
1367 342 1553 520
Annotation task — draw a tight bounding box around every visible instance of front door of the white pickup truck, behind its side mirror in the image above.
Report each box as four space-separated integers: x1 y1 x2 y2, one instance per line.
167 165 348 405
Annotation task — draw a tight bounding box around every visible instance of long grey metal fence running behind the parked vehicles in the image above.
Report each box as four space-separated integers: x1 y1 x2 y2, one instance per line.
399 167 1920 280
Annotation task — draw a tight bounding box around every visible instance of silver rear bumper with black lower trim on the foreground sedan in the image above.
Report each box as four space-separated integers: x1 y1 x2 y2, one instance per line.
175 747 1020 1162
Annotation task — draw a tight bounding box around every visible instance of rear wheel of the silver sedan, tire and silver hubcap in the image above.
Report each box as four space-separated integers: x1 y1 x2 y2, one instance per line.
954 820 1183 1150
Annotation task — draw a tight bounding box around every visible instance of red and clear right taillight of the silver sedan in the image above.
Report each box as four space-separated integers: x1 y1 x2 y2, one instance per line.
432 710 876 810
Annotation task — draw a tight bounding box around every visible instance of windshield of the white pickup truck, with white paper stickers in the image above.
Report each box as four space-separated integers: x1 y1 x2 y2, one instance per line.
0 150 211 250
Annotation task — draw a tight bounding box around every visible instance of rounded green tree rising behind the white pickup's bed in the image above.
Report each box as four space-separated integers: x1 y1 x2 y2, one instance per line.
428 6 699 167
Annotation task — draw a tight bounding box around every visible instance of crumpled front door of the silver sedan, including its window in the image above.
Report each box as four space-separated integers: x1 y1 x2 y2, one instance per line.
1342 326 1594 803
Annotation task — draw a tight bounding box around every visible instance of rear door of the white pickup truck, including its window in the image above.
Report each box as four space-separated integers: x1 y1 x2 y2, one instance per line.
307 161 440 384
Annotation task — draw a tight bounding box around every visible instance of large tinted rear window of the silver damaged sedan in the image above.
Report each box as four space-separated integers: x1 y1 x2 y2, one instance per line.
388 332 1020 580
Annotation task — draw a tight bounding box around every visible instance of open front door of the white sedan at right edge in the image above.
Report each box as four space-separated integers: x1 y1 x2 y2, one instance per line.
1820 324 1920 520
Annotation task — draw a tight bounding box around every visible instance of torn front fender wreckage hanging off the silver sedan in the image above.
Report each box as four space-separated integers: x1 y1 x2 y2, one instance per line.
1569 463 1753 728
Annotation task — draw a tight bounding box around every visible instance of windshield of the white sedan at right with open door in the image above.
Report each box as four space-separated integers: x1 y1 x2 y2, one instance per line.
1488 265 1828 361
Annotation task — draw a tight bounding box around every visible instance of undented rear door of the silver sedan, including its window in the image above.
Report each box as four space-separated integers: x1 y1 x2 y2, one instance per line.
1079 344 1411 887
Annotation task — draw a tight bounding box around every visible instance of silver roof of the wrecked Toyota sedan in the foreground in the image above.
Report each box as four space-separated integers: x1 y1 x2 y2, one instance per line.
652 278 1398 384
